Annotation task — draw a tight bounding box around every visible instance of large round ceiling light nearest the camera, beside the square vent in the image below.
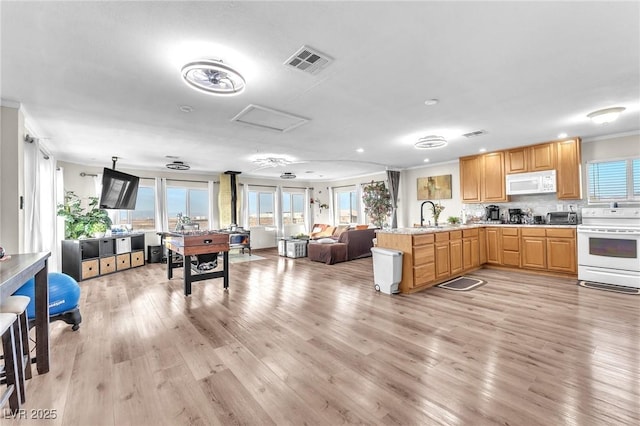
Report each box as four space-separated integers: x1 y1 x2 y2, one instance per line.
182 59 245 96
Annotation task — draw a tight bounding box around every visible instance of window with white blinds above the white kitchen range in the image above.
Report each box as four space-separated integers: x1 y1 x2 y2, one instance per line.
587 158 640 203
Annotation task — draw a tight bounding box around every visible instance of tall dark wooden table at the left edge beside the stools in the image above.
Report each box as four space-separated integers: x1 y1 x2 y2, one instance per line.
0 252 51 374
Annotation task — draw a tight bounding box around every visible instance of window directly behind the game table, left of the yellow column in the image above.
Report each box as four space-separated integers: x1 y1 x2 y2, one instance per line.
167 184 209 229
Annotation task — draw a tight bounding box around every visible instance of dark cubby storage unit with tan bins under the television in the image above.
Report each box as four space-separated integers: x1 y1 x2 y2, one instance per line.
62 234 145 281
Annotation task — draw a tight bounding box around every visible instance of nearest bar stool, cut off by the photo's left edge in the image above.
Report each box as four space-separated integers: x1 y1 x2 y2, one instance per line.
0 313 22 413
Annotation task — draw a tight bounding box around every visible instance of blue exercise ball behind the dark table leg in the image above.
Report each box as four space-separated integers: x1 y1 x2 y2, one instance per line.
14 272 80 319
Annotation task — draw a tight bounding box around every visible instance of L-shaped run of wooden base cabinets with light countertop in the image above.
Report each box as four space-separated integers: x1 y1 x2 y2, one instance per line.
376 224 577 293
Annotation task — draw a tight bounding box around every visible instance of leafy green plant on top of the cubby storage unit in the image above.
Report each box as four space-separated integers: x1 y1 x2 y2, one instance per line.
57 191 111 240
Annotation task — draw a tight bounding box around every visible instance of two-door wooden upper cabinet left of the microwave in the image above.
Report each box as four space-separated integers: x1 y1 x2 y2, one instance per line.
460 151 508 203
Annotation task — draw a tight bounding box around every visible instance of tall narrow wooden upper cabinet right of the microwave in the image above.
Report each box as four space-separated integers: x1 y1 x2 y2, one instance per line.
555 138 582 200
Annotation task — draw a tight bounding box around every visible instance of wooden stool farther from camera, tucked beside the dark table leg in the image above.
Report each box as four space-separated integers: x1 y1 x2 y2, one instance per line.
0 295 32 403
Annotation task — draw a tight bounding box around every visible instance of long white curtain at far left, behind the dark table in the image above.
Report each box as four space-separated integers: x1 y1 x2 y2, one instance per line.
23 140 64 271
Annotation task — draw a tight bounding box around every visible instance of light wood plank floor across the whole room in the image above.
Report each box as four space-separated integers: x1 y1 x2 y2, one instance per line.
1 250 640 426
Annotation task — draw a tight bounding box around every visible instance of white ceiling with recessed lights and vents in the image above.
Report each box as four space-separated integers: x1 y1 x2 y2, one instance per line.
0 1 640 180
